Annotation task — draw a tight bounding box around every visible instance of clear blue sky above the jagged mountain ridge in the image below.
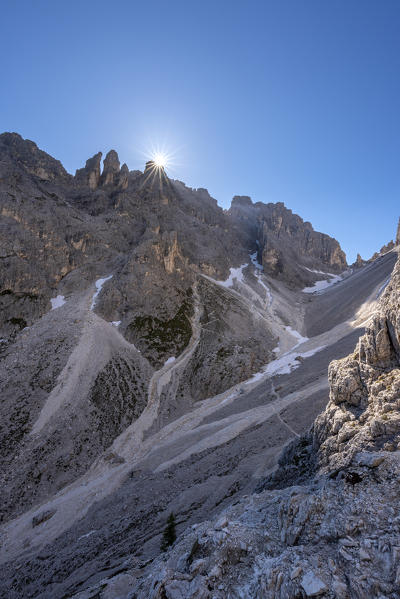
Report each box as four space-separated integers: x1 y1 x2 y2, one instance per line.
0 0 400 261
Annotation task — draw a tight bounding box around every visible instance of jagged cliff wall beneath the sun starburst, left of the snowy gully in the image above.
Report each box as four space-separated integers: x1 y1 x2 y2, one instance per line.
0 134 244 336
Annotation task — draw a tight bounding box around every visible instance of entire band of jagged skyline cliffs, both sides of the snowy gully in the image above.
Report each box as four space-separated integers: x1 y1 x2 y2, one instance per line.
0 133 345 356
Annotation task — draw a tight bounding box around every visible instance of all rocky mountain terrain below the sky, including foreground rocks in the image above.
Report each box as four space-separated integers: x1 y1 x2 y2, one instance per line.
0 133 400 599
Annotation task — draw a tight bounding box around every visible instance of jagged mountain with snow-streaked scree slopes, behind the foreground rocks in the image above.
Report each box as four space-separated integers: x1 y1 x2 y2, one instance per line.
0 133 397 599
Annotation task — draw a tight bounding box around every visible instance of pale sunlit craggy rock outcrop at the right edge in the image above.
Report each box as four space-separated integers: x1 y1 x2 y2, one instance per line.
314 250 400 470
